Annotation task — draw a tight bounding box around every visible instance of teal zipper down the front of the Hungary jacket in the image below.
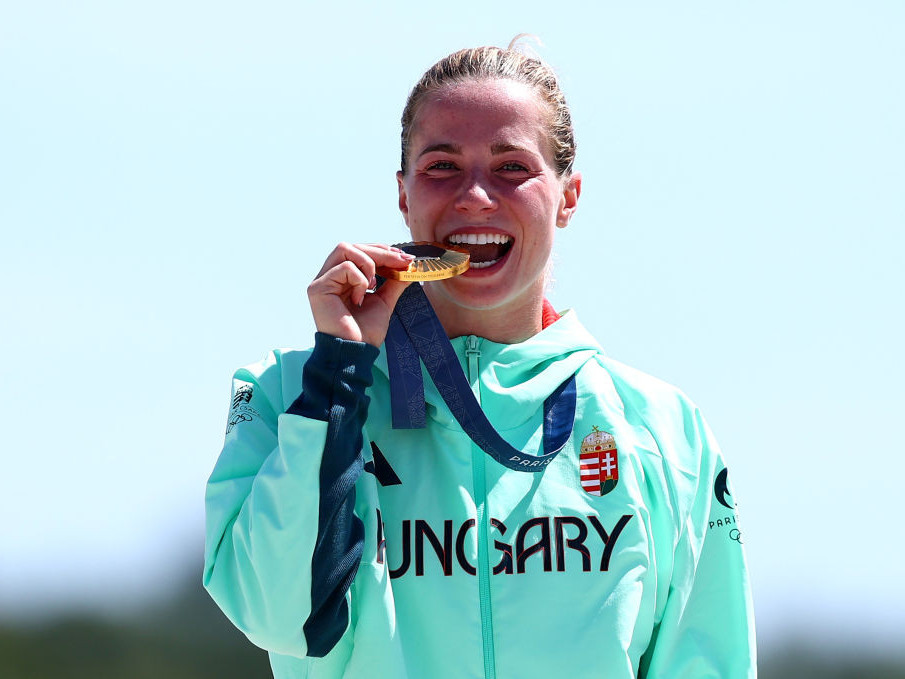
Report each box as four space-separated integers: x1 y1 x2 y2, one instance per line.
465 335 496 679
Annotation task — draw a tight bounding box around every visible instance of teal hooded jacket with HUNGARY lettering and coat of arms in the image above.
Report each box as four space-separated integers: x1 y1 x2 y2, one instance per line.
204 312 756 679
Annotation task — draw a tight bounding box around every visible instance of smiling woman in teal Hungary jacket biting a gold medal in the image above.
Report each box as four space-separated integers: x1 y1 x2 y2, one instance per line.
205 43 755 679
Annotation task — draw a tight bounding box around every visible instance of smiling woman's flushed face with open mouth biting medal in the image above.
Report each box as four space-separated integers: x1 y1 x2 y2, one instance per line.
397 80 581 310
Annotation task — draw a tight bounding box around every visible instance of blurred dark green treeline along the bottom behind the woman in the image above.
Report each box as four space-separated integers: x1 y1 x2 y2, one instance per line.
0 566 905 679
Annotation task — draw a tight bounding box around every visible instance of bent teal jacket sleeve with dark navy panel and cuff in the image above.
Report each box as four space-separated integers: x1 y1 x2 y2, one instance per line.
204 333 378 657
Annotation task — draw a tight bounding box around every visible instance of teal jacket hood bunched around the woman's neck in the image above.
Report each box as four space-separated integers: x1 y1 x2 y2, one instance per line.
375 310 603 431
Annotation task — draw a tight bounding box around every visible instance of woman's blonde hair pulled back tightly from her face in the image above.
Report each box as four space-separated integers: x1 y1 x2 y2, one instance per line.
401 34 576 177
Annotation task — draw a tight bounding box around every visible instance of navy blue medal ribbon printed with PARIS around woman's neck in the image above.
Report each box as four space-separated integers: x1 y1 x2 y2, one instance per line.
386 283 576 472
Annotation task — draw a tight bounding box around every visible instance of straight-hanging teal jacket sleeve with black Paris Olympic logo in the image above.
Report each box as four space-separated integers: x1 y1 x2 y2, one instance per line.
639 409 757 679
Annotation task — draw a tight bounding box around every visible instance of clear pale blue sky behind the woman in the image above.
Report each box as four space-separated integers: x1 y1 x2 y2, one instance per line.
0 0 905 644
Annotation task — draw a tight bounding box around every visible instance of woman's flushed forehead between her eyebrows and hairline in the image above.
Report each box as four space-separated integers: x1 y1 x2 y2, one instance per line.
412 80 548 153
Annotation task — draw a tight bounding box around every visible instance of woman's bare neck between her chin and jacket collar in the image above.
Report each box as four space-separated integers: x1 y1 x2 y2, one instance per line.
425 285 544 344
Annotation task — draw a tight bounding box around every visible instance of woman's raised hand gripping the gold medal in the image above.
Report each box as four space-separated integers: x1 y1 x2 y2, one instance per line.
308 243 414 347
